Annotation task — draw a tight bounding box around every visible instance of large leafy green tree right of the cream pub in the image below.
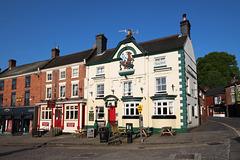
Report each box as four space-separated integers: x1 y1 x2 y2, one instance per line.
197 52 240 88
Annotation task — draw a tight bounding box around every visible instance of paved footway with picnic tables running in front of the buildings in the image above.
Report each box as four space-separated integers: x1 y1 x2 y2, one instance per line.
0 119 236 149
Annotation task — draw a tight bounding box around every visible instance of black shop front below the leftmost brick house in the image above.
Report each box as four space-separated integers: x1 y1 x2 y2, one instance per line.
0 106 37 135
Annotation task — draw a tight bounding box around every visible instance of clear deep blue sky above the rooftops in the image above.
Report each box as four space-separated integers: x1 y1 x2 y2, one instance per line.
0 0 240 70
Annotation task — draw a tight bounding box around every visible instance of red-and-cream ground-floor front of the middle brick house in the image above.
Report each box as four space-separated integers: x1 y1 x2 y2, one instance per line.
38 100 86 133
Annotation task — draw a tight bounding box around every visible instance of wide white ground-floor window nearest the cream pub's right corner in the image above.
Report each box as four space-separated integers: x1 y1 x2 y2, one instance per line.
153 100 174 115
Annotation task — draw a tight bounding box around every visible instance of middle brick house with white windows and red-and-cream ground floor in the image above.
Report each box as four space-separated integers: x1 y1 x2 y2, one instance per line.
36 47 93 132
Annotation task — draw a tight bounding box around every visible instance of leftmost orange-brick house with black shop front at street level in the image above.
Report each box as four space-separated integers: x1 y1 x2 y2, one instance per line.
0 59 49 134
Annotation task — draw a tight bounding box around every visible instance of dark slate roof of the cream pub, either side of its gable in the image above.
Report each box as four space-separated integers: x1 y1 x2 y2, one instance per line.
87 34 187 65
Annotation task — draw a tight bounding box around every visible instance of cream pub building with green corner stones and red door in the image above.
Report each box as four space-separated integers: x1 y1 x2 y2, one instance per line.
84 15 199 133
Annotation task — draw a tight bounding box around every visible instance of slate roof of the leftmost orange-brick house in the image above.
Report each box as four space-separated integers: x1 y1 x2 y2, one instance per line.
0 60 50 78
